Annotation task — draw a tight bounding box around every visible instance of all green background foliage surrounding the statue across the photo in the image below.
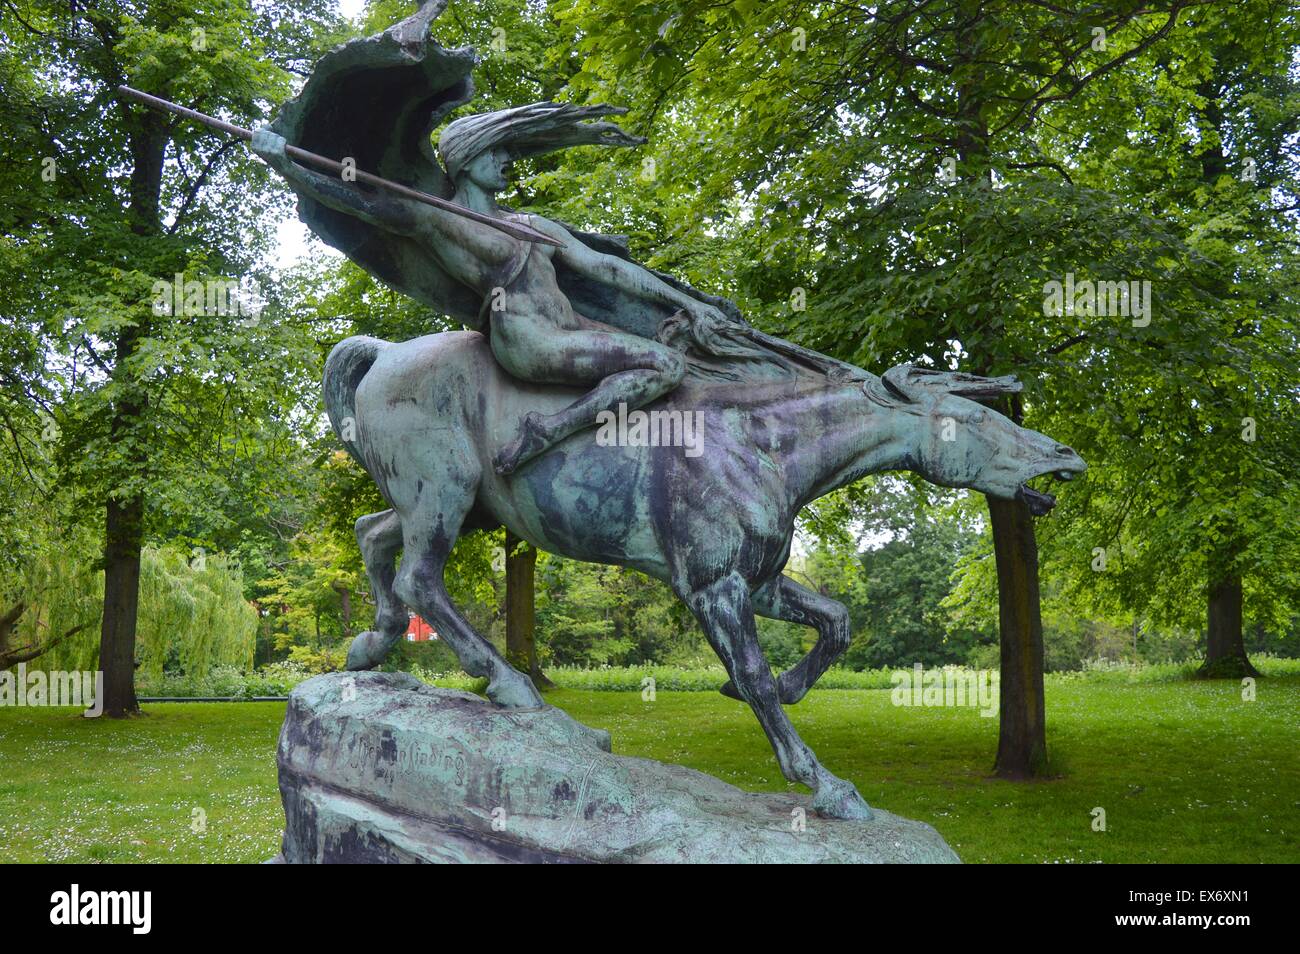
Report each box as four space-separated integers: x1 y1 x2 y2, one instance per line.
0 0 1300 696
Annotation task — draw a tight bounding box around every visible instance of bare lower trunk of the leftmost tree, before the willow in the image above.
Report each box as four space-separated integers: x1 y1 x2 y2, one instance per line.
99 495 144 719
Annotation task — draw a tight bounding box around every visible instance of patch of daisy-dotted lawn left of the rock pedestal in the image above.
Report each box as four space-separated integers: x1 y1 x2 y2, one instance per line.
0 702 285 862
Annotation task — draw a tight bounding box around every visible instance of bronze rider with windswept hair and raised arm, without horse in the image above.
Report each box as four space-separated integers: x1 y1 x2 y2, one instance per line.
252 103 748 474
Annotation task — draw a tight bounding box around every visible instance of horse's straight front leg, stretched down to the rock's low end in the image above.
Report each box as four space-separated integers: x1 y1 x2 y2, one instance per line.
684 572 871 819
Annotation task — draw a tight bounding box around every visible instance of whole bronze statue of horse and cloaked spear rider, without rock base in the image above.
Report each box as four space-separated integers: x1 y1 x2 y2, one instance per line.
139 0 1086 819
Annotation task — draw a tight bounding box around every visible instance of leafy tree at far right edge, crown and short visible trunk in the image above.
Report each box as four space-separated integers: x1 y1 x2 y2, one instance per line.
1024 4 1300 677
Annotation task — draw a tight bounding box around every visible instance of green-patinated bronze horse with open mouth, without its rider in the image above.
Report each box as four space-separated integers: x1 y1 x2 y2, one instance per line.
325 331 1087 819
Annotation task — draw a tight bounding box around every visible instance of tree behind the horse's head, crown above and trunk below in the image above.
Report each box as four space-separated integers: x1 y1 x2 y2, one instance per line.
559 0 1216 777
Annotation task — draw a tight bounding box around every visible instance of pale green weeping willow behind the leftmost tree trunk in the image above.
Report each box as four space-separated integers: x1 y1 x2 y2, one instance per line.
18 541 257 676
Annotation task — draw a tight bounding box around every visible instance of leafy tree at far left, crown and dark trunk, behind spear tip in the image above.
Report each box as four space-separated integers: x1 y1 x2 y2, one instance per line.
0 0 343 716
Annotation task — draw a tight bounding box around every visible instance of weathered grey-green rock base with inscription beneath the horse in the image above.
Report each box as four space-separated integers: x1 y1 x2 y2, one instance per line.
276 672 958 863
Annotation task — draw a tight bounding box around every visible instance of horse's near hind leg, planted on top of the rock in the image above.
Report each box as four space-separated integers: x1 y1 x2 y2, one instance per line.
394 506 545 708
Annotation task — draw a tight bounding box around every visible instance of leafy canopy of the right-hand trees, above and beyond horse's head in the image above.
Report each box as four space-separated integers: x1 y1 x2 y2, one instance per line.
555 0 1300 660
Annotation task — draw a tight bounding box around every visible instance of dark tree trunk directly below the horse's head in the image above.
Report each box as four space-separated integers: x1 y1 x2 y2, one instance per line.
988 498 1048 779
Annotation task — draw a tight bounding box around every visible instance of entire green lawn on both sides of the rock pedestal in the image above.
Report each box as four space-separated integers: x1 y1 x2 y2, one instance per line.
0 676 1300 863
